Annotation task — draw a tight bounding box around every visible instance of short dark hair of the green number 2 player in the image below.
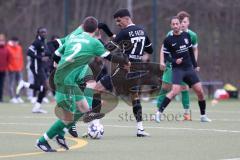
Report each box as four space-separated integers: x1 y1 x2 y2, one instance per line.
83 16 98 33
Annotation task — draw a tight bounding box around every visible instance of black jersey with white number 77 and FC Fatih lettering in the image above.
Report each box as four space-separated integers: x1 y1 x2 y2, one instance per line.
113 24 152 62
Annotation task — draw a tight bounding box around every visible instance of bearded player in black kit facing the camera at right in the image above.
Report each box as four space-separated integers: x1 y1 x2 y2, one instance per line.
159 17 211 122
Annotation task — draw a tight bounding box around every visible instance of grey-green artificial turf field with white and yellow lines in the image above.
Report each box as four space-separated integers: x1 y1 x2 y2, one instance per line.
0 100 240 160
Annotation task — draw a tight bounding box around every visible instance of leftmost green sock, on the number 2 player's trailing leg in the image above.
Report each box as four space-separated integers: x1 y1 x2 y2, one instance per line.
39 120 66 143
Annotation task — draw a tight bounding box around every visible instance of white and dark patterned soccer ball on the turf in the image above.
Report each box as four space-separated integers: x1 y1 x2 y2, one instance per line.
88 124 104 139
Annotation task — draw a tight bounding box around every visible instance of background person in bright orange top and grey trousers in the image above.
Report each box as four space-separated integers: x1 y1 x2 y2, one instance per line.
7 37 24 103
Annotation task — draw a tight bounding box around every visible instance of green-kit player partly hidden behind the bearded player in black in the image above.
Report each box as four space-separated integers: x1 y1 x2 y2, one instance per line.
156 11 198 122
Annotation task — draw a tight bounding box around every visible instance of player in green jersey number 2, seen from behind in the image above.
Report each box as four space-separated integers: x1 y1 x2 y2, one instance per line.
36 17 110 152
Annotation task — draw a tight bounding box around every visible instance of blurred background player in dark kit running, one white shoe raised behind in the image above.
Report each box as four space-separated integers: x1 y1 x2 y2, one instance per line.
16 27 51 113
